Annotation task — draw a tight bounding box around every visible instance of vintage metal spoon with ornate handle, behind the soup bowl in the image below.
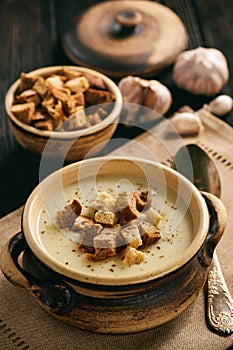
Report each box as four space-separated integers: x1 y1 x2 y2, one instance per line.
173 144 233 335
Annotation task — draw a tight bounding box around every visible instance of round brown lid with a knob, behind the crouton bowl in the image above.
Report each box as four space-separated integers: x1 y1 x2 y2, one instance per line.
64 0 188 77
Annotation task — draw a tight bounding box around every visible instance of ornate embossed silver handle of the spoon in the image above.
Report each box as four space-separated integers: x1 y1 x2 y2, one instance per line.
207 252 233 335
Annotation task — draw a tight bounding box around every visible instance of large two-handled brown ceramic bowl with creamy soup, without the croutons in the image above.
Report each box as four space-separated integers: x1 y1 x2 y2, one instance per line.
1 157 226 334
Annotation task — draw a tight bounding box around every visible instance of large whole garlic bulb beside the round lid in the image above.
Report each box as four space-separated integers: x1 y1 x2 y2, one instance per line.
172 47 229 95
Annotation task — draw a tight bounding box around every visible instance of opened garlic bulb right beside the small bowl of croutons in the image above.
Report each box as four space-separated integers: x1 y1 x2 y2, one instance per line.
118 76 172 124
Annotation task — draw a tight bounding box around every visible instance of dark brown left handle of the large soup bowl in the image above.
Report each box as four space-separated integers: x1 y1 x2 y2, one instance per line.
0 232 77 315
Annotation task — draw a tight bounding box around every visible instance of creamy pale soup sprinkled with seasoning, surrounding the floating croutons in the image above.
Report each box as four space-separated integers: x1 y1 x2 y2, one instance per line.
38 176 195 281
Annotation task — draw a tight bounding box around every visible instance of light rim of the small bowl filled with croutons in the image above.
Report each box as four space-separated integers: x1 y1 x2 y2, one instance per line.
5 64 123 139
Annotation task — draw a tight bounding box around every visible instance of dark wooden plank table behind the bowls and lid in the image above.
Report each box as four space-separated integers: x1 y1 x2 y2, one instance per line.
0 0 233 217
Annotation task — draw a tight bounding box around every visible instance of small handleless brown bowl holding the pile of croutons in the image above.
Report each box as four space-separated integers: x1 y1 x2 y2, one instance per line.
5 66 122 162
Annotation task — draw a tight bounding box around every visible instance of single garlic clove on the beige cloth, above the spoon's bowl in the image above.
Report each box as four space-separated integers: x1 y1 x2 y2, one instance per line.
169 112 203 136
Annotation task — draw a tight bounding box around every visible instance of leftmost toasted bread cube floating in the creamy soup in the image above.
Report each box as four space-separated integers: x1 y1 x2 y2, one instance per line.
57 199 82 228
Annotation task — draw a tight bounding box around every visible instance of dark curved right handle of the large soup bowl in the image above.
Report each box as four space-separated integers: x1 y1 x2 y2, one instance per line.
199 192 227 267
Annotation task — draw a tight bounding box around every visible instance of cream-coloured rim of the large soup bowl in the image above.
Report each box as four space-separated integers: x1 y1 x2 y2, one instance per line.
22 156 209 286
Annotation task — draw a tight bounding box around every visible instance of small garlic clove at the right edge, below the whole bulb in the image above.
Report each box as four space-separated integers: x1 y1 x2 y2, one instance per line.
207 95 233 117
